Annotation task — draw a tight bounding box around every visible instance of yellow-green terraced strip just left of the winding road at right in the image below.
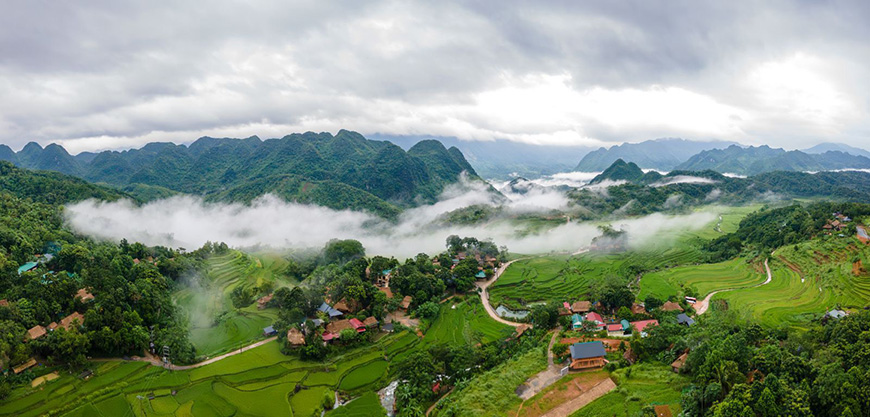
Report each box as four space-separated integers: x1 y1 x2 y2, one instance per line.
638 258 767 300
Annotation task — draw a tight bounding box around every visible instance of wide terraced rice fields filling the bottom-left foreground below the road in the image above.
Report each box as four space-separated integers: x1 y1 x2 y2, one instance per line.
0 333 417 417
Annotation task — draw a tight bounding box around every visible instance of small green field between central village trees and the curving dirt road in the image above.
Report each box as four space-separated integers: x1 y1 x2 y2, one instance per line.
423 295 514 345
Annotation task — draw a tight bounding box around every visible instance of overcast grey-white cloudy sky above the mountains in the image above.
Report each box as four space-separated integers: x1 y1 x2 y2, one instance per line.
0 0 870 153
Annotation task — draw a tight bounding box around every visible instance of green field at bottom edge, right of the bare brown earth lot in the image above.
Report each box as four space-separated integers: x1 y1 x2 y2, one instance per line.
571 364 690 417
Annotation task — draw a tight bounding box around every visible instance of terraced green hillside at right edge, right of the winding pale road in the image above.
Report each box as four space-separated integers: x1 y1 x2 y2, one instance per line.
714 237 870 327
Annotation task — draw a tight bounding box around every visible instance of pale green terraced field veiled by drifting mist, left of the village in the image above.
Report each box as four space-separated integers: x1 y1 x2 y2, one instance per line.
173 251 295 356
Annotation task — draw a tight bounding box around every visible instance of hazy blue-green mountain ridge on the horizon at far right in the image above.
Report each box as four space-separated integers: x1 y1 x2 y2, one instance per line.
674 145 870 175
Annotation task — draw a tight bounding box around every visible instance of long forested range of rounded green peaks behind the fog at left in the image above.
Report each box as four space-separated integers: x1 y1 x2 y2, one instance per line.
0 130 479 217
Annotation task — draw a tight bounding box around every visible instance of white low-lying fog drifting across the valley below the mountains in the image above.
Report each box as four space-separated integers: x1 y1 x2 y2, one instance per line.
65 175 715 258
